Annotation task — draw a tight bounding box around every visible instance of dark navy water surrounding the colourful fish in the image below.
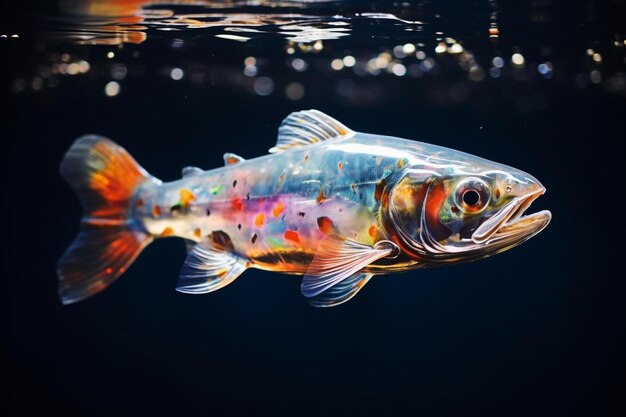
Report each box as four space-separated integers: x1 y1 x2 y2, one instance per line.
0 0 626 416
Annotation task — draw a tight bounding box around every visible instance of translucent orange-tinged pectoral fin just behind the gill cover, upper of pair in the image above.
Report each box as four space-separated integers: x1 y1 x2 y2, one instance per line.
301 234 398 301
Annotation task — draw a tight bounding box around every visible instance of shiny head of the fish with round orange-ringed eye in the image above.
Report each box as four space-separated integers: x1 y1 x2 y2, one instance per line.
388 159 552 263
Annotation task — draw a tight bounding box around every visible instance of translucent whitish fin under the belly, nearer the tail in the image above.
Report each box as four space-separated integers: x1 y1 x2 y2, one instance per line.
176 239 246 294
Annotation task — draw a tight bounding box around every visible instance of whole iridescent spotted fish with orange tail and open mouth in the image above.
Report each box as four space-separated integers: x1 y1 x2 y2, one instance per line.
57 110 552 307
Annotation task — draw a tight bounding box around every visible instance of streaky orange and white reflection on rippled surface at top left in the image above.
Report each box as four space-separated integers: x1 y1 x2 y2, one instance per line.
52 0 422 45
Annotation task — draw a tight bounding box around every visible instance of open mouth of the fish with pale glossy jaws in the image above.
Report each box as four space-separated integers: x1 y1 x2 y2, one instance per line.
471 187 552 244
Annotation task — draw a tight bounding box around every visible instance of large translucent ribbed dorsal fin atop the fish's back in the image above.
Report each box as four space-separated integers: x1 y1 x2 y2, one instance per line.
270 110 354 153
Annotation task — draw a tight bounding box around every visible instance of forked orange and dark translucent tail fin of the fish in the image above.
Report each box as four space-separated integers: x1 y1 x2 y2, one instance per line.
57 135 154 304
